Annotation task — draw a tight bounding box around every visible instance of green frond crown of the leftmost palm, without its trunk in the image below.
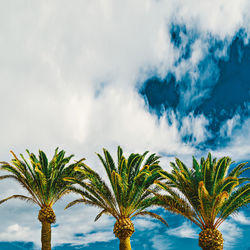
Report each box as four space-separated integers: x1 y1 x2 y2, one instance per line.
0 148 84 207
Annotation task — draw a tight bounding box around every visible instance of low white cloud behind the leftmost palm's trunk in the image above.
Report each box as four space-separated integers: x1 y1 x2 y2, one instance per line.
0 195 115 248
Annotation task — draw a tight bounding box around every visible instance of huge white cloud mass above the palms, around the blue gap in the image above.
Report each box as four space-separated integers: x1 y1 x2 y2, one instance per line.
0 0 248 160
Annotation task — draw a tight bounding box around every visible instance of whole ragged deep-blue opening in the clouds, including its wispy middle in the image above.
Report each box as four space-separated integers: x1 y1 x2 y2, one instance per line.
139 26 250 149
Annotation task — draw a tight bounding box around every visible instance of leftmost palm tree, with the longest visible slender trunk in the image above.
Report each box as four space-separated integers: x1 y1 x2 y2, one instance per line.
0 148 84 250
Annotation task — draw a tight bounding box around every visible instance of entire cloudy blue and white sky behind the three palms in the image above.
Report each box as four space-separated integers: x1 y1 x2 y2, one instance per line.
0 0 250 250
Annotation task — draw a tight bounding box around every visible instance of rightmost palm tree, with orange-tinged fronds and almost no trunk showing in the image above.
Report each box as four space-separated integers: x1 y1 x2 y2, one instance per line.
157 153 250 250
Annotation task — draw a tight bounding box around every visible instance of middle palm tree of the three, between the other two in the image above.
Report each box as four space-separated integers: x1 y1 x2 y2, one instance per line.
66 147 167 250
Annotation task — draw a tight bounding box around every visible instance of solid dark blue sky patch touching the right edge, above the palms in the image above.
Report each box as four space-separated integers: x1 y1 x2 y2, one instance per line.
195 38 250 143
